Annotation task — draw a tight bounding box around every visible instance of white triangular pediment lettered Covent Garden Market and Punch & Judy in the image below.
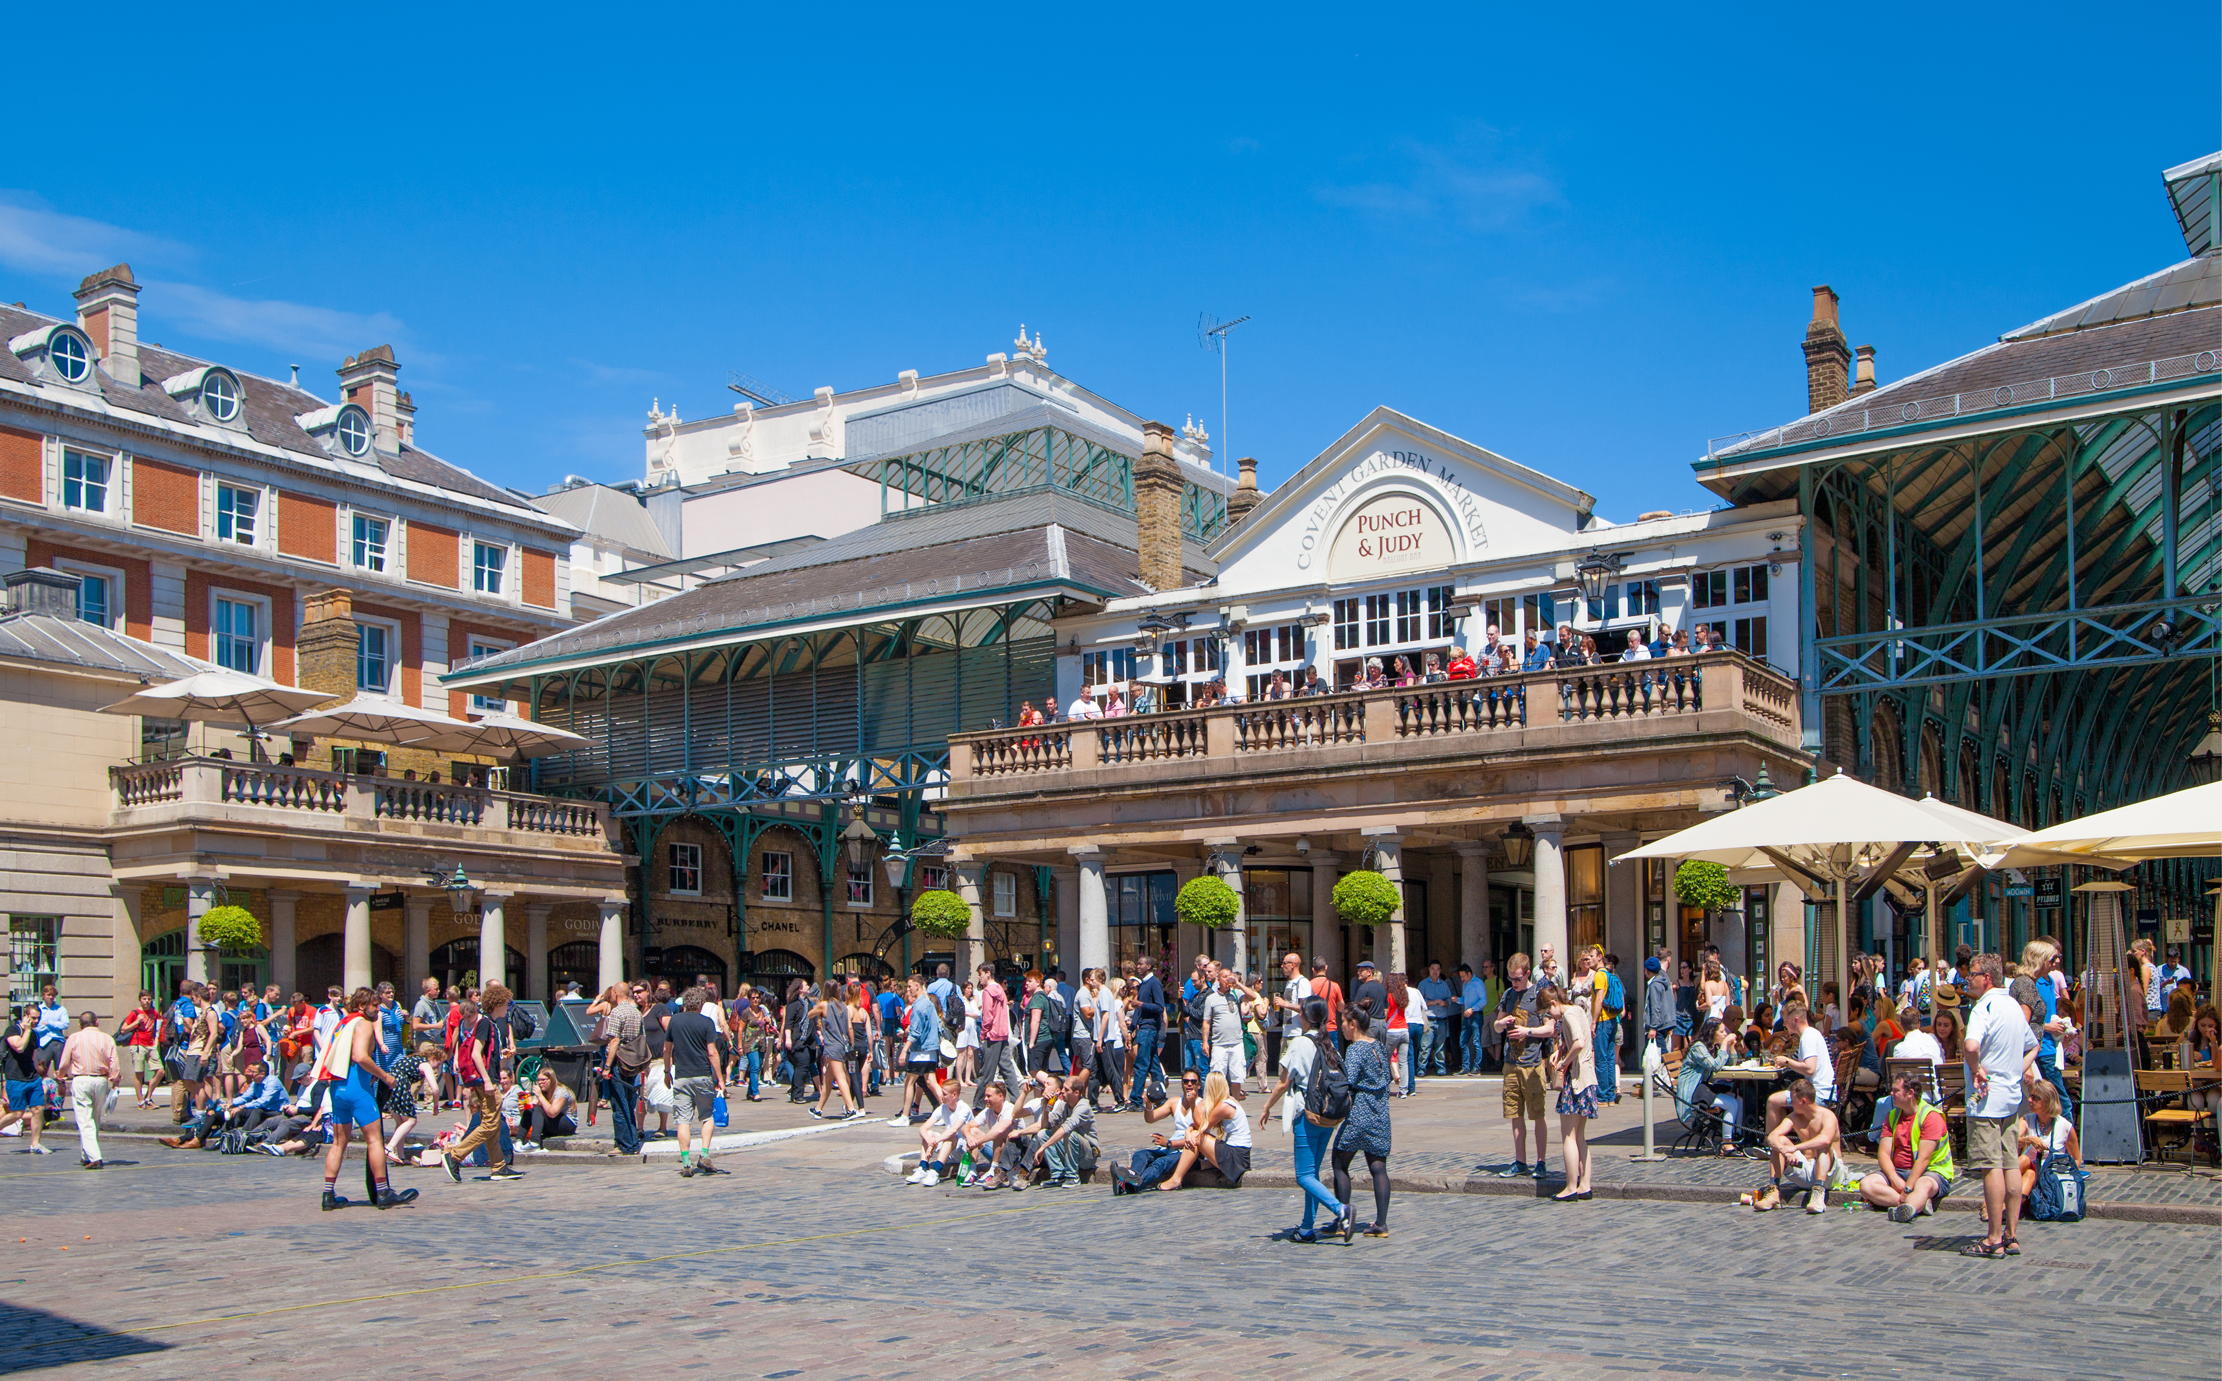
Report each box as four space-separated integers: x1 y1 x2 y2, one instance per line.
1213 409 1595 595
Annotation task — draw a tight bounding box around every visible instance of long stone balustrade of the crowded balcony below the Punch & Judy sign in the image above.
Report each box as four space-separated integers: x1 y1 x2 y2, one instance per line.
949 653 1798 782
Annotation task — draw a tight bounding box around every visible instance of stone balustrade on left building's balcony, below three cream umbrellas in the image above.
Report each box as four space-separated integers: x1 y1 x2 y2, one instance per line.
109 757 604 837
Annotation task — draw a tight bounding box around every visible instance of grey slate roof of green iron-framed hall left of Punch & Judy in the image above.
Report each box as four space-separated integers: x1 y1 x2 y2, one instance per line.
447 488 1211 684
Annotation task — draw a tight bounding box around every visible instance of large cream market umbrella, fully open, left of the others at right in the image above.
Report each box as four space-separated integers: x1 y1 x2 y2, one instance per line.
1613 773 2011 997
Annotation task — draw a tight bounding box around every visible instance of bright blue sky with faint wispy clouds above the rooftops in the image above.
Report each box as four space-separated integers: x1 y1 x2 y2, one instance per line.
0 2 2222 517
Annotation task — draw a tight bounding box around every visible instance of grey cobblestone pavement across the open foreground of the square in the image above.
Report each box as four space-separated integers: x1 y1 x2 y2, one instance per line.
0 1128 2222 1381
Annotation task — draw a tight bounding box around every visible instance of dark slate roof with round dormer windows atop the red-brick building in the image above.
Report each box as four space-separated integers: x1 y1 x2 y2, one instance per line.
0 306 531 511
